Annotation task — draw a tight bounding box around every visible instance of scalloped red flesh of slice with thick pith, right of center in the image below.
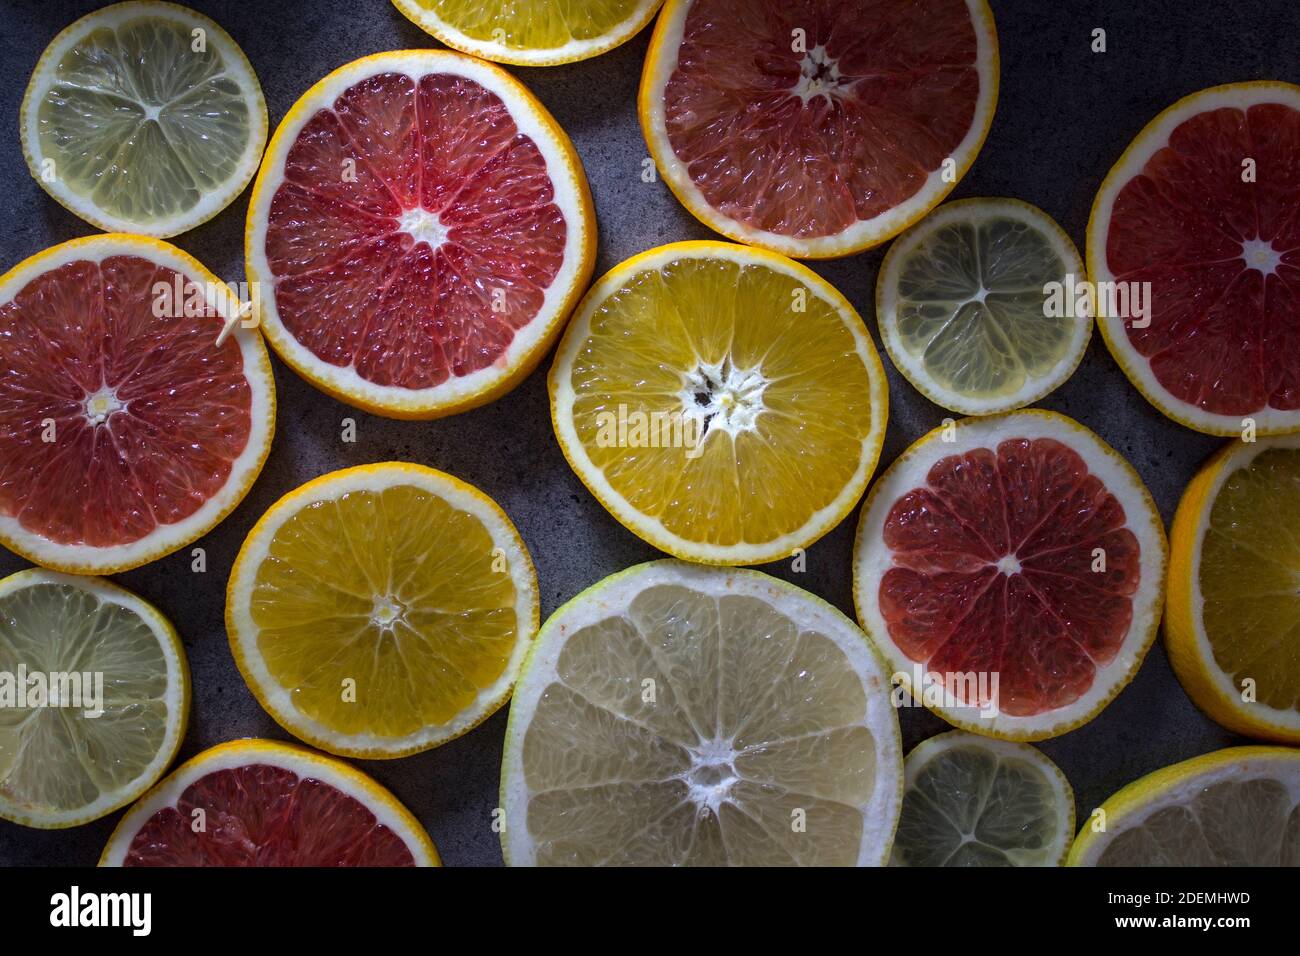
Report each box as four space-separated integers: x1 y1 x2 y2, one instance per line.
879 438 1141 717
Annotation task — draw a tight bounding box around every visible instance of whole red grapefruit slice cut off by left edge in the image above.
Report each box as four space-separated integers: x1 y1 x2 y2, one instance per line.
0 234 276 574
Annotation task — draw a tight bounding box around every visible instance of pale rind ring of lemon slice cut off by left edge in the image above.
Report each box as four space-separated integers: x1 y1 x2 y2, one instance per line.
0 567 190 827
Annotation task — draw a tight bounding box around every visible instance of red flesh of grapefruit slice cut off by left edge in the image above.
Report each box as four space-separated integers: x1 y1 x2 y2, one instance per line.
0 254 256 548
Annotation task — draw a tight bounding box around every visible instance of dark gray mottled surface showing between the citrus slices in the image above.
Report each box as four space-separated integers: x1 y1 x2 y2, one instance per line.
0 0 1300 865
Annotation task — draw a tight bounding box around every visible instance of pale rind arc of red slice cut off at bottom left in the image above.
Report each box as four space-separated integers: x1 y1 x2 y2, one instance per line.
99 739 438 866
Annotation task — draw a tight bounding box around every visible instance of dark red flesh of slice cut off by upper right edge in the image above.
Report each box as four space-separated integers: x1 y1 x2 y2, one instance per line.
1104 101 1300 416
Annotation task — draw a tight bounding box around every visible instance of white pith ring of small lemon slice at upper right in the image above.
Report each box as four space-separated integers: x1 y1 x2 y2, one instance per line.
876 198 1092 415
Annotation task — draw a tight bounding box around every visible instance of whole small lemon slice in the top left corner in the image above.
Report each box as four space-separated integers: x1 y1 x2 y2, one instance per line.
21 3 267 237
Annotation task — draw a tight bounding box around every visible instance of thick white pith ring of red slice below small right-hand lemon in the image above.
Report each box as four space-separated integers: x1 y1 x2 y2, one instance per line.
853 411 1166 740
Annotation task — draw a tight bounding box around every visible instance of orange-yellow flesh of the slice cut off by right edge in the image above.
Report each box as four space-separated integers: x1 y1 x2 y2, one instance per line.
1199 447 1300 713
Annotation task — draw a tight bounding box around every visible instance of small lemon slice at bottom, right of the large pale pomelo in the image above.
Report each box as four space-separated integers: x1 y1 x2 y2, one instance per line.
889 730 1074 866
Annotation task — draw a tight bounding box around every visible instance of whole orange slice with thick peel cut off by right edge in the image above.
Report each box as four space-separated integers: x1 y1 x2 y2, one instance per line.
1165 436 1300 744
